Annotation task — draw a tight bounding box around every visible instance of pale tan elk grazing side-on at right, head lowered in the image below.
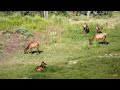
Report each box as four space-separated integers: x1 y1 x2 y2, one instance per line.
89 33 107 45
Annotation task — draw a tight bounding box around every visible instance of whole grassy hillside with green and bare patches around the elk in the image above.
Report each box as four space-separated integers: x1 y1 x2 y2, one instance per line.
0 11 120 79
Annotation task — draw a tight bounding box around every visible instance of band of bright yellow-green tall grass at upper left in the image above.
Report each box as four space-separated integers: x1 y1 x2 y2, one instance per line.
0 12 51 31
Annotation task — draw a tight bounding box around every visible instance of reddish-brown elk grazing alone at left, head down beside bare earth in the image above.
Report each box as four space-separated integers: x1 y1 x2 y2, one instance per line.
24 41 39 54
